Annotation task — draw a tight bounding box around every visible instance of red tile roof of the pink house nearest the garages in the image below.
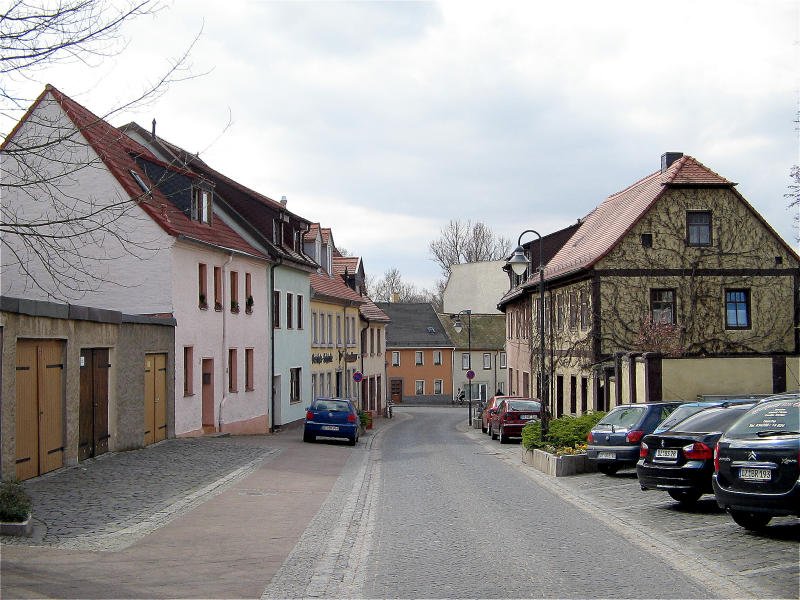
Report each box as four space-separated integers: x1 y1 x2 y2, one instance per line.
35 85 266 258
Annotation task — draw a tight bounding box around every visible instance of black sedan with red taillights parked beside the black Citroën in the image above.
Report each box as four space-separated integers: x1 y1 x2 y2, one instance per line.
636 402 753 505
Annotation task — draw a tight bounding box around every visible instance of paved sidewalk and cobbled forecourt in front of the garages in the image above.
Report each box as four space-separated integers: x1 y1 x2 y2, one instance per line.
0 420 382 598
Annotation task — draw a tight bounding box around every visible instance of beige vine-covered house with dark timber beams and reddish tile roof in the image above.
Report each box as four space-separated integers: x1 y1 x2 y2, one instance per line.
500 153 800 416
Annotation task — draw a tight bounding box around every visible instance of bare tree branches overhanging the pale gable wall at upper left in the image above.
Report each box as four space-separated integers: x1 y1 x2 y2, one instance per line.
0 0 199 300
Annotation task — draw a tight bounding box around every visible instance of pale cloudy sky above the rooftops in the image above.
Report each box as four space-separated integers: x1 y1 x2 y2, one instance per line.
0 0 800 289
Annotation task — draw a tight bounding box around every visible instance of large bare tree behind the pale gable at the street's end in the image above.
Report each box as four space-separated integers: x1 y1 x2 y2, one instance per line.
428 219 511 279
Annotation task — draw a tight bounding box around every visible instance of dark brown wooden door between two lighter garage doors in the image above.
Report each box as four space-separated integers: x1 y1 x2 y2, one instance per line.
78 348 111 460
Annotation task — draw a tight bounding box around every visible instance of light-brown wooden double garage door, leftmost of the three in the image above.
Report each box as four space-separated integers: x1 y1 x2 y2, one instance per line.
16 340 64 479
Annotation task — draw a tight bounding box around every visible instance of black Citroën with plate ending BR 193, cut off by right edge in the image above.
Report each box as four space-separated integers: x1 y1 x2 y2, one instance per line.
712 393 800 529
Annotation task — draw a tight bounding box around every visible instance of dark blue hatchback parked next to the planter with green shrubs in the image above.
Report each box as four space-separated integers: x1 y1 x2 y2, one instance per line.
586 402 681 475
